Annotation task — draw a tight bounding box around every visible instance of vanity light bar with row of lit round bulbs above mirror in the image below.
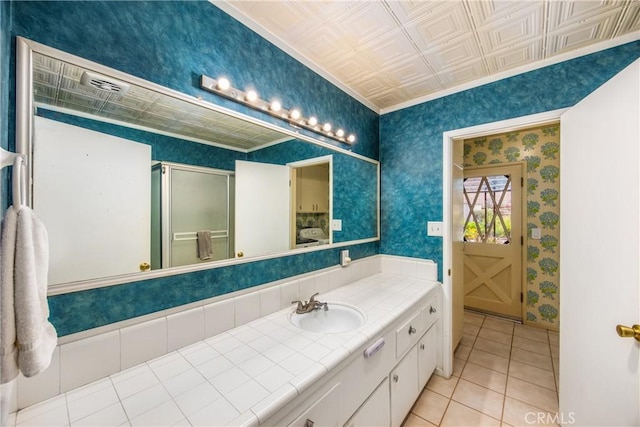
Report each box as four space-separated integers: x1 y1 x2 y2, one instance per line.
200 75 356 144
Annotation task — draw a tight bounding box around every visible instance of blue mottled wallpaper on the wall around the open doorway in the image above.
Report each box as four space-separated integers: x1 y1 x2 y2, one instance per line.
380 42 640 280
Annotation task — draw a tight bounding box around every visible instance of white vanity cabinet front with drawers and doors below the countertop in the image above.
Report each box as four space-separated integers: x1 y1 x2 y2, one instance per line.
264 286 441 427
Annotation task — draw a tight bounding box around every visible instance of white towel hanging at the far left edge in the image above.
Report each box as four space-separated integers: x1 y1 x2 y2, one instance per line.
1 206 57 382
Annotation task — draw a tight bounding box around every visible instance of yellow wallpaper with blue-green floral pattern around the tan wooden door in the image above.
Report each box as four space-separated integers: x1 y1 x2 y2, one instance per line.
464 124 560 329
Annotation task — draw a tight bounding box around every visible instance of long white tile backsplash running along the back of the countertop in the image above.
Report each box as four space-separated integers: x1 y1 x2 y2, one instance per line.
3 255 437 412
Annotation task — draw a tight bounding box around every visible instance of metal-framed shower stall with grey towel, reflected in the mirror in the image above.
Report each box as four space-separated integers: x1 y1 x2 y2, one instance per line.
151 162 234 270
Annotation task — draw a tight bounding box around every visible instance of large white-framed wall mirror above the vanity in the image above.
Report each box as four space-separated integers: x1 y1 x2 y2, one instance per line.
16 38 380 294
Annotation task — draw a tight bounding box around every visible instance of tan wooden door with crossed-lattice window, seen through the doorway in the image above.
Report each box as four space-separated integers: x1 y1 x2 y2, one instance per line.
463 165 522 318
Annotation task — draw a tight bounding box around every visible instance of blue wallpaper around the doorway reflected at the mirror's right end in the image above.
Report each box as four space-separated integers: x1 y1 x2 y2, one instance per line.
249 140 378 243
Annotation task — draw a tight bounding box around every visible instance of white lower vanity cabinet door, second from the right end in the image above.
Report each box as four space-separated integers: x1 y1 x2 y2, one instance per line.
389 346 419 427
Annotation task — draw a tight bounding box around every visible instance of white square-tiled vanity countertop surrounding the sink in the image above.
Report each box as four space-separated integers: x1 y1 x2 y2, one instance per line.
17 273 440 426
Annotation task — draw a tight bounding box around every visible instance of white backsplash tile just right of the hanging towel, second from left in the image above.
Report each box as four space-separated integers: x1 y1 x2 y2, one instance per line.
60 331 120 393
